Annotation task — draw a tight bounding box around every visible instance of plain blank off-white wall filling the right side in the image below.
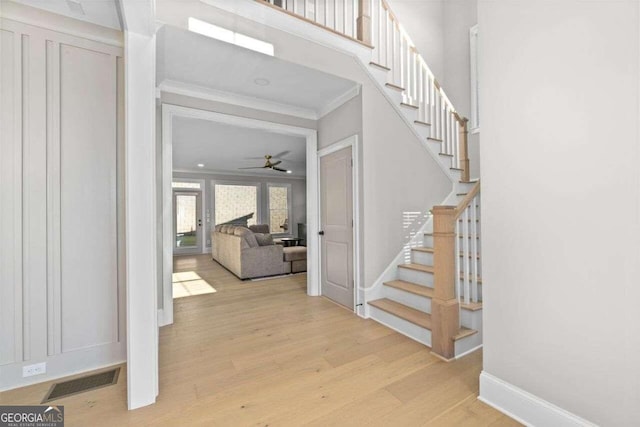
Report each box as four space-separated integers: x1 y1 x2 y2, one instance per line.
478 0 640 426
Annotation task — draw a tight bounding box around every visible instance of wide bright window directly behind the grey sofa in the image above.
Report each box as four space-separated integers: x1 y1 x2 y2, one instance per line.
213 184 259 225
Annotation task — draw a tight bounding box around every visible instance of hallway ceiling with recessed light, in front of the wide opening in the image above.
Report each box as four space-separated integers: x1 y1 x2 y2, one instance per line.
157 25 358 118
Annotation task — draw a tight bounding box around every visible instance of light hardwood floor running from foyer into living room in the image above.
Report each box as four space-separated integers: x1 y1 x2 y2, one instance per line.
0 255 519 427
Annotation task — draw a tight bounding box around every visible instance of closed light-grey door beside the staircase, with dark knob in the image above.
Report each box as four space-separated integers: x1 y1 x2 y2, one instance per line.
320 147 354 309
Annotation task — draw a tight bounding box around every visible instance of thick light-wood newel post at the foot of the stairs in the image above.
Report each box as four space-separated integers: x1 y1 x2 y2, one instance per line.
431 206 460 359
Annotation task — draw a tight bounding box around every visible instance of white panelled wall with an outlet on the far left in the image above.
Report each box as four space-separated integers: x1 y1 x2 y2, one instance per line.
0 4 125 390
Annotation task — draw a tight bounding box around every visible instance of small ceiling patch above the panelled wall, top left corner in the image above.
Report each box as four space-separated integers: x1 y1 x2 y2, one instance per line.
11 0 122 30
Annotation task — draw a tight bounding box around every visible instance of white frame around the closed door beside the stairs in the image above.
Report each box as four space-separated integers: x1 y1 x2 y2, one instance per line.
318 134 364 317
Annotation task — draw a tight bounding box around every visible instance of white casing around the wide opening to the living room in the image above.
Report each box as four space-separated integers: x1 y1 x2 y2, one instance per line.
158 103 320 326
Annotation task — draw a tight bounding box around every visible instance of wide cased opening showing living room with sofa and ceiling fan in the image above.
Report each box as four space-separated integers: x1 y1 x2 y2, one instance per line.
171 116 307 299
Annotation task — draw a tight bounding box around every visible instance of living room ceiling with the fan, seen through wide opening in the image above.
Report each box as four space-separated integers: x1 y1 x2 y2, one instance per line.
172 117 306 178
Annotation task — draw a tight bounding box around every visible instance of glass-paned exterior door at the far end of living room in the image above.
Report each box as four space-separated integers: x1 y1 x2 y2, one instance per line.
173 191 203 255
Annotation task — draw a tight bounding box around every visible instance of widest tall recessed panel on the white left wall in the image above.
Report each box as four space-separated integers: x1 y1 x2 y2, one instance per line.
59 44 118 353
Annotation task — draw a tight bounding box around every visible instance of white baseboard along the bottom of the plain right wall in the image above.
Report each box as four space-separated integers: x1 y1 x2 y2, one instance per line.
478 371 595 427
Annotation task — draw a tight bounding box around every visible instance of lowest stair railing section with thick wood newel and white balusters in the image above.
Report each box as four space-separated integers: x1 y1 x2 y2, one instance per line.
431 181 480 360
